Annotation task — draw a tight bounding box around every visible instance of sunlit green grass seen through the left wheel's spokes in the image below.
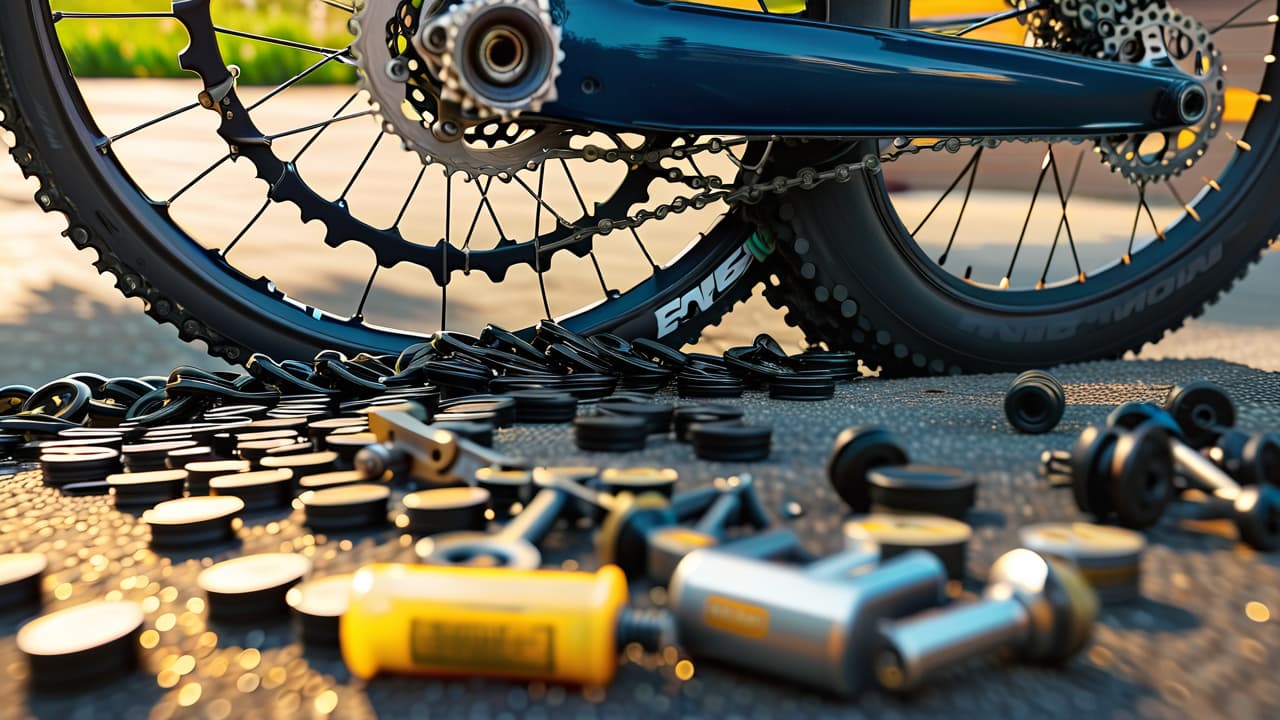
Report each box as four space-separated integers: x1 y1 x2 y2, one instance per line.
51 0 356 85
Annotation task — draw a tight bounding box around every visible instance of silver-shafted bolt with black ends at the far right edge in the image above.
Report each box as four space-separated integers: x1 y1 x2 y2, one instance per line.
1110 404 1280 552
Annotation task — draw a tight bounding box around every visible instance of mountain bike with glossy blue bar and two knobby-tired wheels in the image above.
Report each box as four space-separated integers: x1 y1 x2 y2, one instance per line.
0 0 1280 374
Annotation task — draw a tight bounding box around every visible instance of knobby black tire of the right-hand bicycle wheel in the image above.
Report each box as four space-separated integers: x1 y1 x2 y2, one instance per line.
759 0 1280 375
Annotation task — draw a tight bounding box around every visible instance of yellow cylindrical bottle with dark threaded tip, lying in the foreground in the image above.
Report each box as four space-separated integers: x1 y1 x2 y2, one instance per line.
340 565 673 685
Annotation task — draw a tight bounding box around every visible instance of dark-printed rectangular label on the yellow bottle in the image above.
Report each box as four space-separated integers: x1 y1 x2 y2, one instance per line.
410 619 556 674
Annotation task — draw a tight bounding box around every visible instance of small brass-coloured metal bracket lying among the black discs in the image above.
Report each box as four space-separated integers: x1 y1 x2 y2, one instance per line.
362 410 521 486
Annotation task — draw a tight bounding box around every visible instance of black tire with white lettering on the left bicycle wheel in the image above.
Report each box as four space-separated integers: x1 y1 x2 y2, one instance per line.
0 0 762 363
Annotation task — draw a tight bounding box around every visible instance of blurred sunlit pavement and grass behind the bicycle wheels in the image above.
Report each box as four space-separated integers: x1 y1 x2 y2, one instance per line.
0 0 1280 384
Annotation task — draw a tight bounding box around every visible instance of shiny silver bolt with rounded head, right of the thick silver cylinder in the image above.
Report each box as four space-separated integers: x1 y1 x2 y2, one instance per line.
873 548 1098 692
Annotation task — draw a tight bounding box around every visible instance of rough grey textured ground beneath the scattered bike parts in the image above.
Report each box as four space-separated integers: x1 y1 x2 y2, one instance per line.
0 361 1280 720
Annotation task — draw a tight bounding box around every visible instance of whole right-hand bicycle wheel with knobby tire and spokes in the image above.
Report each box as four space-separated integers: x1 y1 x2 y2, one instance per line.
763 0 1280 374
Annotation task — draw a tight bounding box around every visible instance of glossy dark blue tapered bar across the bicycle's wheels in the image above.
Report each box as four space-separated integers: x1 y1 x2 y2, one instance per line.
543 0 1208 137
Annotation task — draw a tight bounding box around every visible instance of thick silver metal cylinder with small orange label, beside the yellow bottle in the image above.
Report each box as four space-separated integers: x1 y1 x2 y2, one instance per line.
668 550 947 696
